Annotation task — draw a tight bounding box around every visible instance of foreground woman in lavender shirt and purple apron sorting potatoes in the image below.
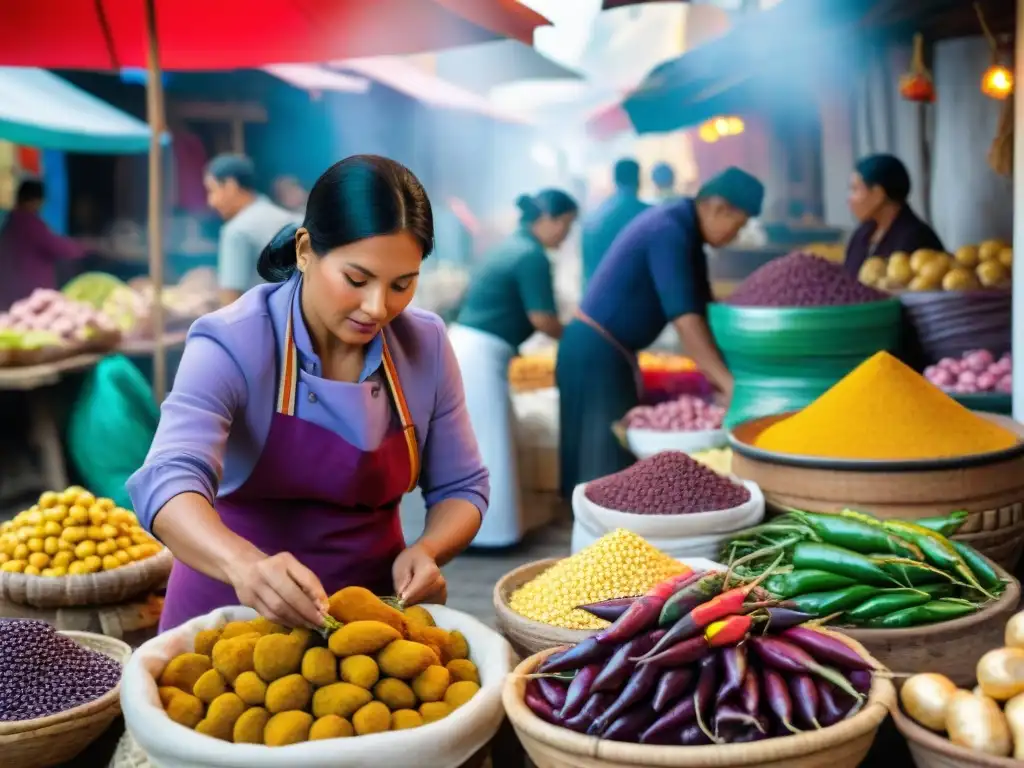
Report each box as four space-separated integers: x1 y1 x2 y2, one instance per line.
128 156 488 629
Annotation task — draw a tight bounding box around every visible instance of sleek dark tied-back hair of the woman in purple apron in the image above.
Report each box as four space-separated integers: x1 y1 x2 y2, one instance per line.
256 155 434 283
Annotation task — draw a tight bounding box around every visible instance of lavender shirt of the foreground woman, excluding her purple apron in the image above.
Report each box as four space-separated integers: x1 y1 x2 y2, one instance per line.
128 275 489 530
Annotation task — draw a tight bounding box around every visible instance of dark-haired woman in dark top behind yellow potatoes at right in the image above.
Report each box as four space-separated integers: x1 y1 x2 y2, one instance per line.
844 155 945 274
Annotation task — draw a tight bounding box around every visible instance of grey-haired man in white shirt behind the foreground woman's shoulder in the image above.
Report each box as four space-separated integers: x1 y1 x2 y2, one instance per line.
203 155 302 305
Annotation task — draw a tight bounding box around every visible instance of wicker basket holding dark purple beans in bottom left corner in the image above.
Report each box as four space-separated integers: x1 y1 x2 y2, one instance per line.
0 632 131 768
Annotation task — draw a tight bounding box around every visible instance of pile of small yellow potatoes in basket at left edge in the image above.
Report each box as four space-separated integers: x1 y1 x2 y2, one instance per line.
0 485 163 578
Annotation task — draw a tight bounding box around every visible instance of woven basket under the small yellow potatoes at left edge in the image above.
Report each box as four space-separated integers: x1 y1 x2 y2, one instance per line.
0 548 174 608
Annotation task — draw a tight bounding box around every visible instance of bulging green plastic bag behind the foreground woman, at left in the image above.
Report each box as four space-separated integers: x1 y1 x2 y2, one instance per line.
68 354 160 509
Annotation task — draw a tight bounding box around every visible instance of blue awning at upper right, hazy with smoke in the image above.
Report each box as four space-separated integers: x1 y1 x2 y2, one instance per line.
623 0 1014 133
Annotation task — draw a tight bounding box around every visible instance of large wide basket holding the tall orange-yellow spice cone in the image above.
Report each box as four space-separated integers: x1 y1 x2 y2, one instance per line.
729 414 1024 570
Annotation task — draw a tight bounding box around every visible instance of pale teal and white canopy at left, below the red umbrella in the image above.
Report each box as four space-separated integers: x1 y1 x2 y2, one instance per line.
0 67 159 155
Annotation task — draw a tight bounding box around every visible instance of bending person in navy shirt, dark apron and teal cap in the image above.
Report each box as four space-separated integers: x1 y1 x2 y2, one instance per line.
556 168 764 498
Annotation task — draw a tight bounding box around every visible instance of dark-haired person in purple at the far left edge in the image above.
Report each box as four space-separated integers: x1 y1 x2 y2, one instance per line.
0 179 86 311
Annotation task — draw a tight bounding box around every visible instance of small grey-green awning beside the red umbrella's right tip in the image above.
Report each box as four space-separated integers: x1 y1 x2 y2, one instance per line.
436 40 583 93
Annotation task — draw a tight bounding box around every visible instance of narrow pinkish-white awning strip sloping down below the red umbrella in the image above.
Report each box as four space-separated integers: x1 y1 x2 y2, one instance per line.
333 56 529 123
